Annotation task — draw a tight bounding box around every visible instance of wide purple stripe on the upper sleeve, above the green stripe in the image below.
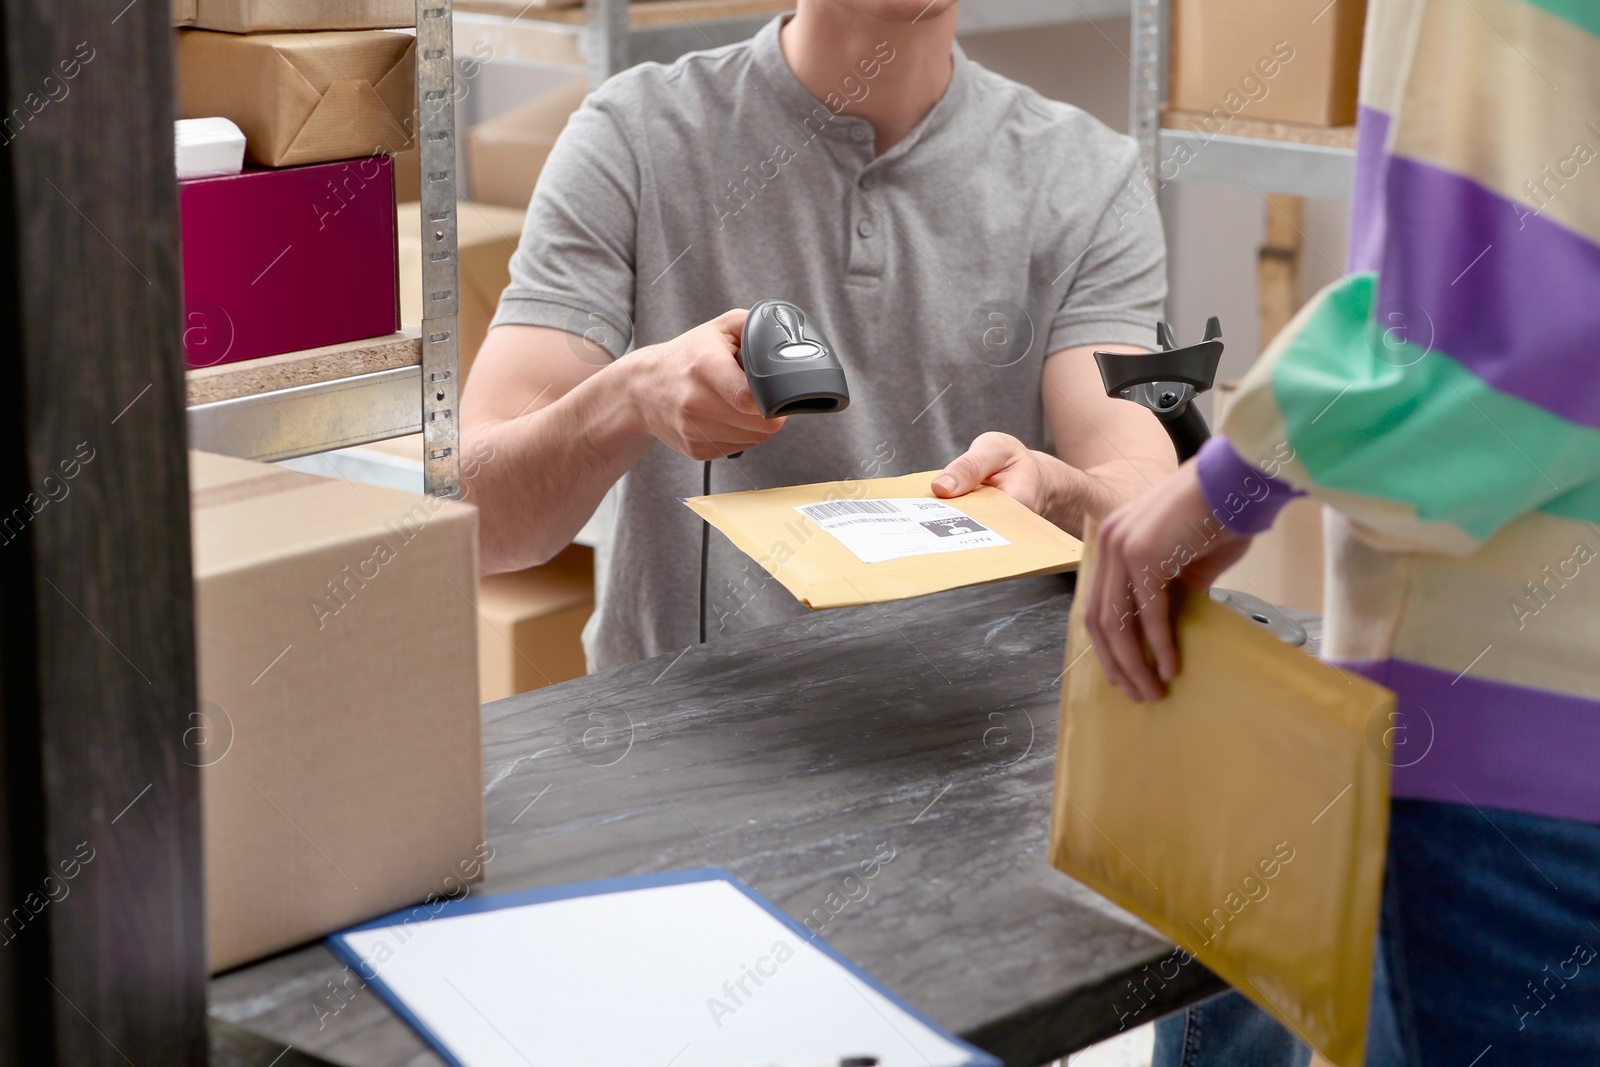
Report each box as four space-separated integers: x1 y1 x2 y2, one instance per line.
1373 157 1600 427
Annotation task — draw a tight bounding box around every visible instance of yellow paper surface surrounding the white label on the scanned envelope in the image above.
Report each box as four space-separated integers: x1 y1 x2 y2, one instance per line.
683 470 1083 609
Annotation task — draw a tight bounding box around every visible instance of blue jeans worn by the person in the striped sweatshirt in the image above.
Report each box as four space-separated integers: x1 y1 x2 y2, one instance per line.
1150 799 1600 1067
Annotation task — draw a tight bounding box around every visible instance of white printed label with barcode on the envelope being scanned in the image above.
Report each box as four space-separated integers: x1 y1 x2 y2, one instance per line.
795 498 1011 563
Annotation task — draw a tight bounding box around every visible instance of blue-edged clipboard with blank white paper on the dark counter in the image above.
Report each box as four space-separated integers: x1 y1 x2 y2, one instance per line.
326 867 1002 1067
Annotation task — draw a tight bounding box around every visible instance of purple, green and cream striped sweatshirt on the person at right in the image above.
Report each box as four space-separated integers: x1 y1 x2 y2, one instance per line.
1197 0 1600 822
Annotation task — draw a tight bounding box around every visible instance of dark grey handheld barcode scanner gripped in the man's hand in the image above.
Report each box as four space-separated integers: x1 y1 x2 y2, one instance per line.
739 299 850 419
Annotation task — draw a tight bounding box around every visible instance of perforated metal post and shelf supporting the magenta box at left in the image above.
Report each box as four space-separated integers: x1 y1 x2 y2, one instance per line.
187 0 461 498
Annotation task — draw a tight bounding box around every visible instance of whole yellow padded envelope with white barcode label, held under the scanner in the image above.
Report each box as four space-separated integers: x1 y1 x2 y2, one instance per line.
683 470 1083 609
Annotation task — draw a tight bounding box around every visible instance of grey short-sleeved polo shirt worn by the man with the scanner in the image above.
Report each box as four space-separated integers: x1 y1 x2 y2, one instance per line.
494 12 1166 670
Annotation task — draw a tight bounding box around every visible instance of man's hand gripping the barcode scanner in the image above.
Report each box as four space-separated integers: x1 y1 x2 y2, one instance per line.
616 309 784 459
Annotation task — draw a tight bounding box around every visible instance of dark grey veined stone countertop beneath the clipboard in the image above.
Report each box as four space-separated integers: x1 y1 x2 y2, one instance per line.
211 577 1312 1067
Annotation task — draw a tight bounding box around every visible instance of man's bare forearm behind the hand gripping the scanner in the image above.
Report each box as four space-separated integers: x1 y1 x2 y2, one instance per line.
461 360 654 574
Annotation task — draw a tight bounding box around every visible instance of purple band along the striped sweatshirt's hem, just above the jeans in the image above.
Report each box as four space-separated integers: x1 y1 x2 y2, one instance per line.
1341 659 1600 822
